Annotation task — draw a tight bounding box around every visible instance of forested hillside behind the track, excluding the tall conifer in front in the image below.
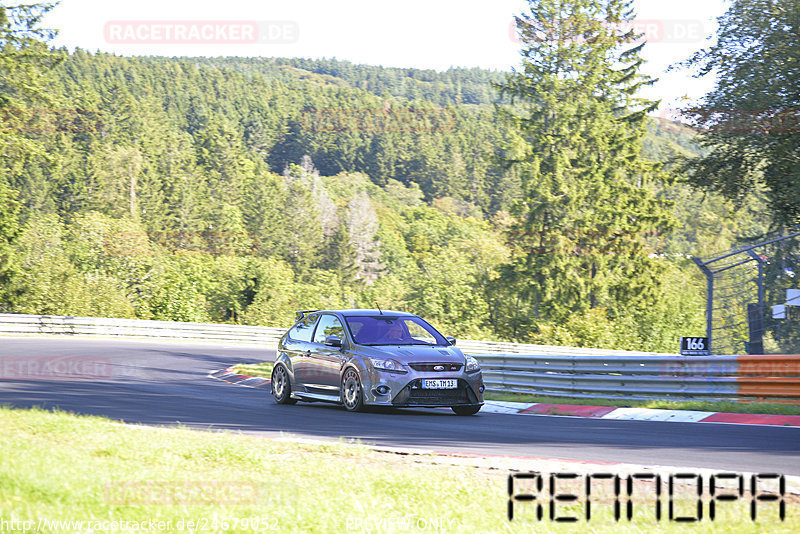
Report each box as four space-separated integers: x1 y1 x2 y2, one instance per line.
0 50 736 350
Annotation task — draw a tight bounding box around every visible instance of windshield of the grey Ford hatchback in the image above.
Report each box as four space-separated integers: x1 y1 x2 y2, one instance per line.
346 315 448 345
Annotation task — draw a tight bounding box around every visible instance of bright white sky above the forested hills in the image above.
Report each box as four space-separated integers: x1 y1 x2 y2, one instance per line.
34 0 726 116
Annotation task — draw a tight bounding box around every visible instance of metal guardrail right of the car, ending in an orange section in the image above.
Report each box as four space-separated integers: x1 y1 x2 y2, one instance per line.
474 354 800 403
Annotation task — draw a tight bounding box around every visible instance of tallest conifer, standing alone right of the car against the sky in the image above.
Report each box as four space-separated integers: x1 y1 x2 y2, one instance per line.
498 0 671 329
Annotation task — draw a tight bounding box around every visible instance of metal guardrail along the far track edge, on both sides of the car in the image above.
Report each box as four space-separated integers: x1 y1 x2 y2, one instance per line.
0 314 800 403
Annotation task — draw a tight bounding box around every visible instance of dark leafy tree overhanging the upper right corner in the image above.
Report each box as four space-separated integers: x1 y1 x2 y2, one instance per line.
685 0 800 228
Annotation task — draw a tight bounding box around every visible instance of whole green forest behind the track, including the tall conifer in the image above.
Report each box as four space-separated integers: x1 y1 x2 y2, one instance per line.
0 0 792 352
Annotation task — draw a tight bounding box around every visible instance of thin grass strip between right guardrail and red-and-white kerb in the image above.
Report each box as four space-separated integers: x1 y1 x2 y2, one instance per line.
486 392 800 415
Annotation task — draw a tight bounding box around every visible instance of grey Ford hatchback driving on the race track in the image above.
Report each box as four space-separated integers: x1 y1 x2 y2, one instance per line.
272 310 484 415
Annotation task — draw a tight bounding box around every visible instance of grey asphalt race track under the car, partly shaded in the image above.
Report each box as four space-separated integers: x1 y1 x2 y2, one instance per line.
0 337 800 475
